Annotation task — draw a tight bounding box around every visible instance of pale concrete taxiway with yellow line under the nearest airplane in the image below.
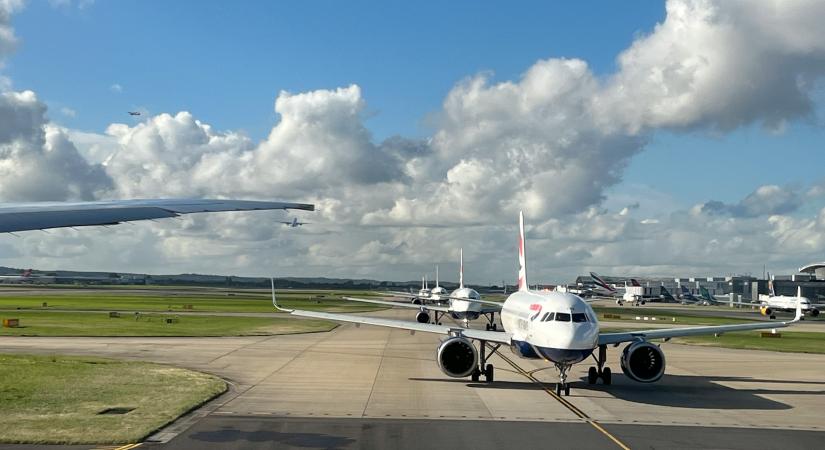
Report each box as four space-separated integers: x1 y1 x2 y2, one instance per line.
0 311 825 449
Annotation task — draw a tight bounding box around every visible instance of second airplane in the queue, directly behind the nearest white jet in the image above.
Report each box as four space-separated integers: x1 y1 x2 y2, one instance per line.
344 249 501 331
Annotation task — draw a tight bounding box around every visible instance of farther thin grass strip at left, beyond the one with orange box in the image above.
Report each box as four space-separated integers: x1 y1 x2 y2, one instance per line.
0 289 381 312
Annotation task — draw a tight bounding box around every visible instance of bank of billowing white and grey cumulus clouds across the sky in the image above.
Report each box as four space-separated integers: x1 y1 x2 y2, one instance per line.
0 0 825 281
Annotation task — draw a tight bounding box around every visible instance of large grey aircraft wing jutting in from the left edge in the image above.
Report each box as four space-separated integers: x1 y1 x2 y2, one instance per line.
0 199 315 233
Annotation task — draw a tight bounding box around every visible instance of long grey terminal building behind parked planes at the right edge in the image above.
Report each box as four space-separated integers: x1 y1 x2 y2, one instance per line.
576 262 825 303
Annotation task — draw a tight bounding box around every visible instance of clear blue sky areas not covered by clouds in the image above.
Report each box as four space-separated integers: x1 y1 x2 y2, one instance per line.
6 1 825 211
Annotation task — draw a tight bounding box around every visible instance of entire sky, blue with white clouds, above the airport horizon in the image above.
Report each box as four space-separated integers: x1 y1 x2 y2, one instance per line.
0 0 825 283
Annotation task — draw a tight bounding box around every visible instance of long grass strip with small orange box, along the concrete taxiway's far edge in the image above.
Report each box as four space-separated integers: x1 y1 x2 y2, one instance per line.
0 311 336 336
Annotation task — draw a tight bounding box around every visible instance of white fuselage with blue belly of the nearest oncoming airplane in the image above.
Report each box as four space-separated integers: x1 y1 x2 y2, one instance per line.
501 291 599 364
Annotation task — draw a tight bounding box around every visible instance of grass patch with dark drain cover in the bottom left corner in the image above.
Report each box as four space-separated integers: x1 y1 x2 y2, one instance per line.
0 355 226 444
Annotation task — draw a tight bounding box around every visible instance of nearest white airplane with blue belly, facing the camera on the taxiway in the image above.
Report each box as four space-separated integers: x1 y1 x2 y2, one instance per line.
272 212 802 395
